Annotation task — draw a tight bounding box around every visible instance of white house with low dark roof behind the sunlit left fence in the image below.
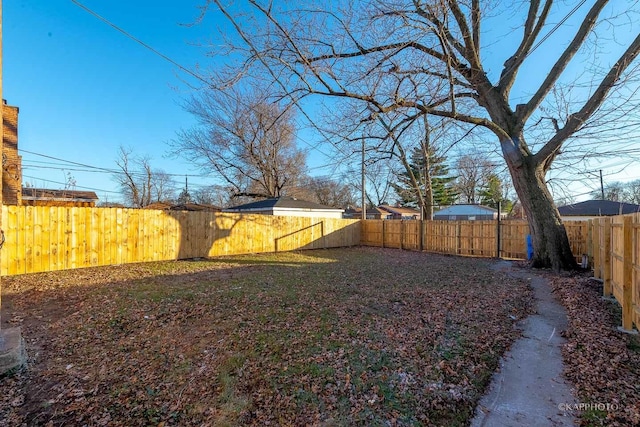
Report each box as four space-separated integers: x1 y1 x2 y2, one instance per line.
223 197 344 218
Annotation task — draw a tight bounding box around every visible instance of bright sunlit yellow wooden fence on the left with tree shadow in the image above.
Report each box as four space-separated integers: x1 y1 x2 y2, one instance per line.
0 206 360 275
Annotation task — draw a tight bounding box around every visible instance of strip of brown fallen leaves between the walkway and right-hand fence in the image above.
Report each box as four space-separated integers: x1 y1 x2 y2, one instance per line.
551 276 640 427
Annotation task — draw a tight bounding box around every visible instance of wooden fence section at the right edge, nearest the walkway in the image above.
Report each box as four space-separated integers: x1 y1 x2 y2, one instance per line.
591 213 640 330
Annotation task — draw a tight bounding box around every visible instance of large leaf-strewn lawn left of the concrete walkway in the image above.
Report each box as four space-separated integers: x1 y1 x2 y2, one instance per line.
0 248 532 426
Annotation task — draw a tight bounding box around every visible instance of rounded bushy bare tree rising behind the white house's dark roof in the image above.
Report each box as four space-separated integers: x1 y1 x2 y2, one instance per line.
173 88 305 198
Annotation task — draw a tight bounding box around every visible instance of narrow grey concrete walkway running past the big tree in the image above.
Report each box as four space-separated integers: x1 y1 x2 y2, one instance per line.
471 261 576 427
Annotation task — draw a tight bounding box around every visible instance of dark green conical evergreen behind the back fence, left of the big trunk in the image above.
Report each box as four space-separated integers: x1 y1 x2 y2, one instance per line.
392 146 457 208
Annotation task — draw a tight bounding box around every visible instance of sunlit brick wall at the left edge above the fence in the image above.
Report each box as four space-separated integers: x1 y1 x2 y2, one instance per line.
2 100 22 205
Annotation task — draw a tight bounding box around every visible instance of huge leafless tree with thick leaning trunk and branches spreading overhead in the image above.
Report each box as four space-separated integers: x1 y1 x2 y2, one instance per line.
208 0 640 269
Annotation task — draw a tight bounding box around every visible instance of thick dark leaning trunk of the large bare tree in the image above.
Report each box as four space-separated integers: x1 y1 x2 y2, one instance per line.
505 156 577 271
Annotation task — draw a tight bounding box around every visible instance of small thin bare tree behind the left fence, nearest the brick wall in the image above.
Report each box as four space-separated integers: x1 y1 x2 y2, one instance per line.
113 147 175 208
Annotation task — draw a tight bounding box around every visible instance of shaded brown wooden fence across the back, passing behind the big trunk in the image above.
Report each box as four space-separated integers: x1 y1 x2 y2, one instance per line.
362 220 589 260
